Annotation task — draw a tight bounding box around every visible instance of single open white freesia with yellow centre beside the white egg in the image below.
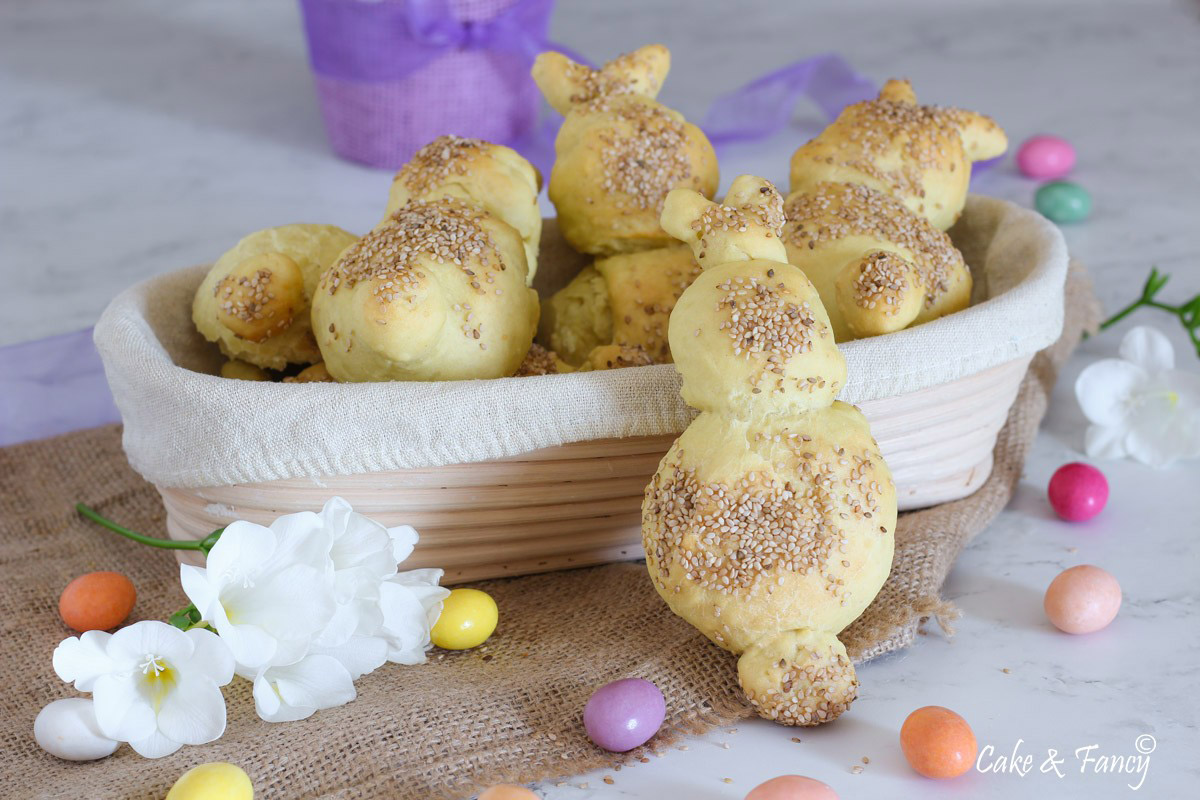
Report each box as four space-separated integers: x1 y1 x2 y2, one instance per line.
54 621 234 758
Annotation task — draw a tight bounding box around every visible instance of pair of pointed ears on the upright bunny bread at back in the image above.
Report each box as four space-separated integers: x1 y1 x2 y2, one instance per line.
532 44 671 115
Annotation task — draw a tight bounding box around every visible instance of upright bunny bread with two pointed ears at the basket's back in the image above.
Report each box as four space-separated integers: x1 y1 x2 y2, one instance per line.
533 44 718 255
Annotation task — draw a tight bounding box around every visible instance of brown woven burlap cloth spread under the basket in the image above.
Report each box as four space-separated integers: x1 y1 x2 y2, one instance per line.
0 267 1098 800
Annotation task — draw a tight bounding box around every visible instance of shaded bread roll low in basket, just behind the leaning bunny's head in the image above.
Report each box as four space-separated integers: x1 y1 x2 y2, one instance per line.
538 245 700 368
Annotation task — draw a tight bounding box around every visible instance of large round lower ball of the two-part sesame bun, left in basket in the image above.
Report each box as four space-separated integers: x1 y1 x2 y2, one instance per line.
312 197 538 381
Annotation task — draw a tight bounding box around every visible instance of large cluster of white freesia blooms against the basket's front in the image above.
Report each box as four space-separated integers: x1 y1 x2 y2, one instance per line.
189 498 449 722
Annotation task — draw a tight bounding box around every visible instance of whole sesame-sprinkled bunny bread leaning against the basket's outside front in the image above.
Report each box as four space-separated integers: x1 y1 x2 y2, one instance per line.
642 175 896 726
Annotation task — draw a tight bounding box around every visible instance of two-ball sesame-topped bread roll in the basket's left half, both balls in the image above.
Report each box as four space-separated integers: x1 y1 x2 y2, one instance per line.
312 137 541 381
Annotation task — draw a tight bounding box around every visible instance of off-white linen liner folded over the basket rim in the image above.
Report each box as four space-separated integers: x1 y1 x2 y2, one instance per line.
95 196 1068 488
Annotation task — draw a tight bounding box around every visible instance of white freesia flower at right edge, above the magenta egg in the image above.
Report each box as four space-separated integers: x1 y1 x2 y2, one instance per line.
1075 326 1200 467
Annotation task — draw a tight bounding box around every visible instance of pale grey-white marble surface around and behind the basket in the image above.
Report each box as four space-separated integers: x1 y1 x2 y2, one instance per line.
0 0 1200 800
